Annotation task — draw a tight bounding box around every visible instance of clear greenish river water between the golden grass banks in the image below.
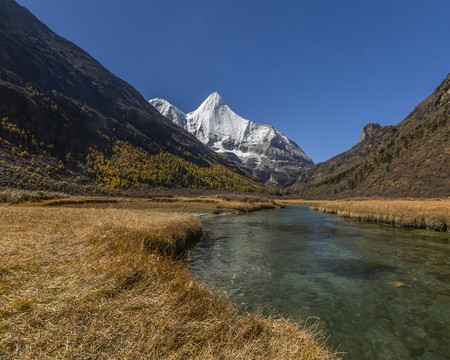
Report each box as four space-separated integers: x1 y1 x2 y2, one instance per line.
189 206 450 360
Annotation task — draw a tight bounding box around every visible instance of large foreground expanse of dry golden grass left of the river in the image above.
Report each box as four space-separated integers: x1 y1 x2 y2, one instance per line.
0 204 336 360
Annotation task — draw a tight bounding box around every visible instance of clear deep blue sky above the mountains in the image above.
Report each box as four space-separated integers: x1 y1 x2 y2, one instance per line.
18 0 450 162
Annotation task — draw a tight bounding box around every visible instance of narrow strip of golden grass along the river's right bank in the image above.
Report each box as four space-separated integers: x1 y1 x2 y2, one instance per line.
283 199 450 232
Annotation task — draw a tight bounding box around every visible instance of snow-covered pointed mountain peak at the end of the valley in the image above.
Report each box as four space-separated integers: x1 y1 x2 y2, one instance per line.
150 92 314 186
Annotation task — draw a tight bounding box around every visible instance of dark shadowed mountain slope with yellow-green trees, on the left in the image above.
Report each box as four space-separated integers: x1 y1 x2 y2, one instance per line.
0 0 268 194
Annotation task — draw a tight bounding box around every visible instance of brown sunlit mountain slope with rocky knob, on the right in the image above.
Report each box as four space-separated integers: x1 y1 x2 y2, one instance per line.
290 74 450 198
